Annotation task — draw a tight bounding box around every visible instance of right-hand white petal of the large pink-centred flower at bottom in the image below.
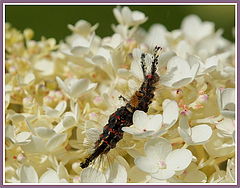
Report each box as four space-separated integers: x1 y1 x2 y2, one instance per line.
166 149 193 171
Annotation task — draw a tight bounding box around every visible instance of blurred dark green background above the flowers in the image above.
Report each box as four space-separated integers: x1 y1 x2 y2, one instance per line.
5 5 235 41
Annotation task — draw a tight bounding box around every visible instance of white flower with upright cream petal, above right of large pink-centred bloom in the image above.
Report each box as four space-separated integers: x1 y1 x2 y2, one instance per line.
178 115 212 145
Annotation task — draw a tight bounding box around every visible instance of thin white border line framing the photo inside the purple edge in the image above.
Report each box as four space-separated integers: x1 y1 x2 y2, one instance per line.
2 2 238 186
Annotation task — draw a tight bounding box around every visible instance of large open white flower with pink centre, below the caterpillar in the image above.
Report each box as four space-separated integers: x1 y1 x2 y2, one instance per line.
135 138 193 180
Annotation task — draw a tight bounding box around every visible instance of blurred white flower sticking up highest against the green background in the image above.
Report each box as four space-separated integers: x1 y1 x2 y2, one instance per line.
113 7 147 26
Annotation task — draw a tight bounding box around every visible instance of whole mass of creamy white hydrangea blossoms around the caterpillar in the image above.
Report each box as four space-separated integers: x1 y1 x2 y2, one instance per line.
5 7 236 183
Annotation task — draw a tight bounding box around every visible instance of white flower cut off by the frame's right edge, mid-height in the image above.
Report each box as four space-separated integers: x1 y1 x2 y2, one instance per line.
216 88 236 119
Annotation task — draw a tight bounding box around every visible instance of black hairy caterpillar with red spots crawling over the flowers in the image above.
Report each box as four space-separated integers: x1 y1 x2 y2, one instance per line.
80 46 162 168
